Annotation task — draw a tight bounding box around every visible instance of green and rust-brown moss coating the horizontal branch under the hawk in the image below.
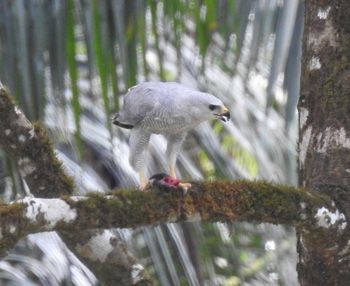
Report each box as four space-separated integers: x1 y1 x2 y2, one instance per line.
69 180 334 228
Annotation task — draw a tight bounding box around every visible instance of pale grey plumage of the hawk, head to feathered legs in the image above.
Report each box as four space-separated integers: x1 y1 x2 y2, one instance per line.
113 82 230 188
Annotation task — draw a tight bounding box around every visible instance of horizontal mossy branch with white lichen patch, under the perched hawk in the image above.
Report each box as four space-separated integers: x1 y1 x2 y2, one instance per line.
0 180 343 253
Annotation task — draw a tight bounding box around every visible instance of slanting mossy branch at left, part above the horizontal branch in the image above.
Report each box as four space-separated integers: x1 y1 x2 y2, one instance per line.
0 85 73 198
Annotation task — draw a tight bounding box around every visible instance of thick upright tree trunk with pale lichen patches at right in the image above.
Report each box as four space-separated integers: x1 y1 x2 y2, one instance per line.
297 0 350 285
